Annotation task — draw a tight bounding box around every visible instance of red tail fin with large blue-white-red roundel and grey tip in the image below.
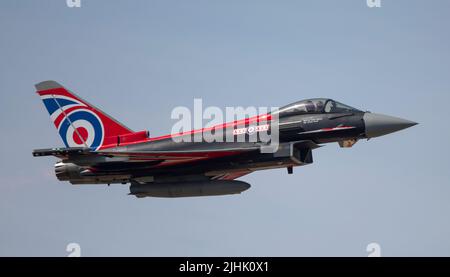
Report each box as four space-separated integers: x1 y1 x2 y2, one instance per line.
36 81 133 150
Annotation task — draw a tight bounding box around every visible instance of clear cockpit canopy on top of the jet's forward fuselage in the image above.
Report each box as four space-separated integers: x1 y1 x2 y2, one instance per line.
278 98 361 117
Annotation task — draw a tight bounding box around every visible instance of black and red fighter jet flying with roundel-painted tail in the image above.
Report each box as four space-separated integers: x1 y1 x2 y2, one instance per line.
33 81 417 198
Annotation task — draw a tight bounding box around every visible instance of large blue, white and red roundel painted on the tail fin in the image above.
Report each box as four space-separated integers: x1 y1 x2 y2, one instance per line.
41 95 105 150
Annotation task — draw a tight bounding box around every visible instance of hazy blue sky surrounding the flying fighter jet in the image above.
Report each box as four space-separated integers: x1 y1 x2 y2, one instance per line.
0 0 450 256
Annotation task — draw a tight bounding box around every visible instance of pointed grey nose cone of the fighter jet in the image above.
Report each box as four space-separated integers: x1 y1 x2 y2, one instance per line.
363 113 417 138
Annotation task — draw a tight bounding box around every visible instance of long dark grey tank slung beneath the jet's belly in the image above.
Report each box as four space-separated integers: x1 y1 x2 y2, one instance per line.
130 180 250 198
